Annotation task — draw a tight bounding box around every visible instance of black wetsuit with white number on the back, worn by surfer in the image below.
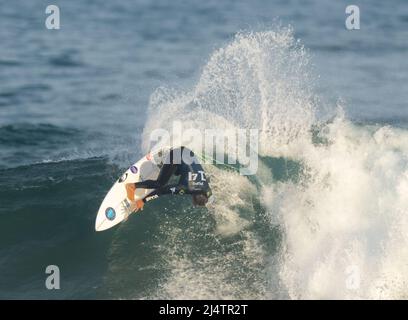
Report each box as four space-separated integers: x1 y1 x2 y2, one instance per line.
135 147 211 202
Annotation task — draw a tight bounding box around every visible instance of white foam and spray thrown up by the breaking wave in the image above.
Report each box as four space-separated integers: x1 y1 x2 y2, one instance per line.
138 29 408 299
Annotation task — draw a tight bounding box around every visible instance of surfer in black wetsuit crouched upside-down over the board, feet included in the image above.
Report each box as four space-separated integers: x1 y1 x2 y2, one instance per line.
126 147 212 210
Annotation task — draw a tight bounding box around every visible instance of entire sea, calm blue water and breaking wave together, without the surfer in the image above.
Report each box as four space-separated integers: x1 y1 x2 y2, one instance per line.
0 0 408 299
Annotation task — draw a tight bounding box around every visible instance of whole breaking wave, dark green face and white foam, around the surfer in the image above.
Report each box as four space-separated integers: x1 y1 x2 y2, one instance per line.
0 29 408 299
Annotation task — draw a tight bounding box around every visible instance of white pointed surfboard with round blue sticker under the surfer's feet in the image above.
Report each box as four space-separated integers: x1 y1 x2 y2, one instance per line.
95 147 168 231
